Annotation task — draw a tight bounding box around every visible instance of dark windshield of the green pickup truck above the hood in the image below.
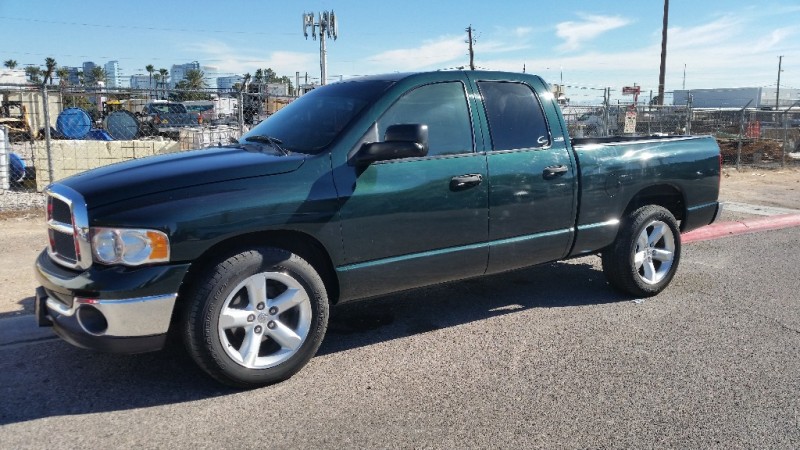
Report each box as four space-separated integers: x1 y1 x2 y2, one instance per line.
240 80 392 153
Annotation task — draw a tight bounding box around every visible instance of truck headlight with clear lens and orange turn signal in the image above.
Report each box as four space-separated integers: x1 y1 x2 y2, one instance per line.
92 228 169 266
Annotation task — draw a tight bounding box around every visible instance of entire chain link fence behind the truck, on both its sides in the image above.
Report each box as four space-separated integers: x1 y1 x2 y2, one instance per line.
0 85 800 195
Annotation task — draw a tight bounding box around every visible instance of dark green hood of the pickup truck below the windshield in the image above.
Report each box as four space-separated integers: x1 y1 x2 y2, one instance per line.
58 145 308 208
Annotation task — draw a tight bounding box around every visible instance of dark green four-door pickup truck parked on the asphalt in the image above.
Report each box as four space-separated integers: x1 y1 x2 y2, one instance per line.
35 71 721 388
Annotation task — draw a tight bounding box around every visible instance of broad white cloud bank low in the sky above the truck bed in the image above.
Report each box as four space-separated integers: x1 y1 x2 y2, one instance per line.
481 14 800 97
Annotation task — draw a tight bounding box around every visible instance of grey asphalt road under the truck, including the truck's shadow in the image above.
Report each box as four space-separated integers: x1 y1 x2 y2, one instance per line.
0 228 800 449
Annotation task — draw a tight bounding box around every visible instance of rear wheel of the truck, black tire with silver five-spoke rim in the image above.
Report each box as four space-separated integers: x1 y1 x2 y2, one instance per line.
602 205 681 297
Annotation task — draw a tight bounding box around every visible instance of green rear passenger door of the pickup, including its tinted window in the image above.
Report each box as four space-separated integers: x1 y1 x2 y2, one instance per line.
477 79 577 273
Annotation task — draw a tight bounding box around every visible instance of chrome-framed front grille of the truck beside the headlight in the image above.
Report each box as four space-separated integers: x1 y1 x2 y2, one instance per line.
45 184 92 269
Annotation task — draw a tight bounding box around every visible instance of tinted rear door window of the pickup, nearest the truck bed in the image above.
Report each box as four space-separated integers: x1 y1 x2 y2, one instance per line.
478 81 550 150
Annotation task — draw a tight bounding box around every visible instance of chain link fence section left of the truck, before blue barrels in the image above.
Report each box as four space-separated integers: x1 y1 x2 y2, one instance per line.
0 85 300 192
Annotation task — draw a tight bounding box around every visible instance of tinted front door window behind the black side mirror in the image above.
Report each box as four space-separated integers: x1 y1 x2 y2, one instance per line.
377 82 473 156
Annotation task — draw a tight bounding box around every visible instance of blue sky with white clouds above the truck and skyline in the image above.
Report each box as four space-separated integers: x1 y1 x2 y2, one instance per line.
0 0 800 102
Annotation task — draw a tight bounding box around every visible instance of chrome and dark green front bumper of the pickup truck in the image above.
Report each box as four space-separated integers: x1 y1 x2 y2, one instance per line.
35 252 188 353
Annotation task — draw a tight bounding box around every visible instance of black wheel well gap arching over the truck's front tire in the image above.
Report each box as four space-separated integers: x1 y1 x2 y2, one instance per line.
173 230 339 318
